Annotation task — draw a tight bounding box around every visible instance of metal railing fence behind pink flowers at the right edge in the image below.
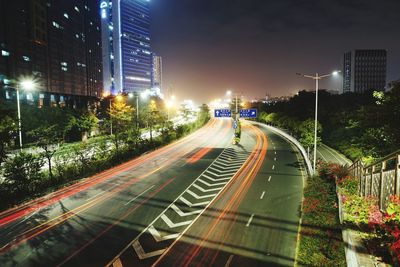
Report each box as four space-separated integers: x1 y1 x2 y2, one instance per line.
350 150 400 211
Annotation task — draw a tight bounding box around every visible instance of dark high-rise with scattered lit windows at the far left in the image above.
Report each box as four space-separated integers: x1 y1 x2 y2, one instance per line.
0 0 103 107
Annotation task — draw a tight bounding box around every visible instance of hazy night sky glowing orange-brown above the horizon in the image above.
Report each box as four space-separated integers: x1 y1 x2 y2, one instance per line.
151 0 400 103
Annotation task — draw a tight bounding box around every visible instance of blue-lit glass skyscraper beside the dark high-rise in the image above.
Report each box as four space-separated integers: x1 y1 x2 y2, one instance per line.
100 0 153 94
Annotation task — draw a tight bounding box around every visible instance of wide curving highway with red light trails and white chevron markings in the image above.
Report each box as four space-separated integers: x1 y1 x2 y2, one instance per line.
0 120 305 266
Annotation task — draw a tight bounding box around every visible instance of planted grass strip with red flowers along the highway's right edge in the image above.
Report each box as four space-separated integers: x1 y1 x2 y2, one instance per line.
296 176 346 266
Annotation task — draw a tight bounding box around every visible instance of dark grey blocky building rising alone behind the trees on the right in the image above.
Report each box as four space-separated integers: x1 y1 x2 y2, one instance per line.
343 50 387 93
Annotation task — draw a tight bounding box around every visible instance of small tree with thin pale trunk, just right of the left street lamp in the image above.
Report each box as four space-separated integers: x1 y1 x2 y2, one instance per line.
28 125 62 178
